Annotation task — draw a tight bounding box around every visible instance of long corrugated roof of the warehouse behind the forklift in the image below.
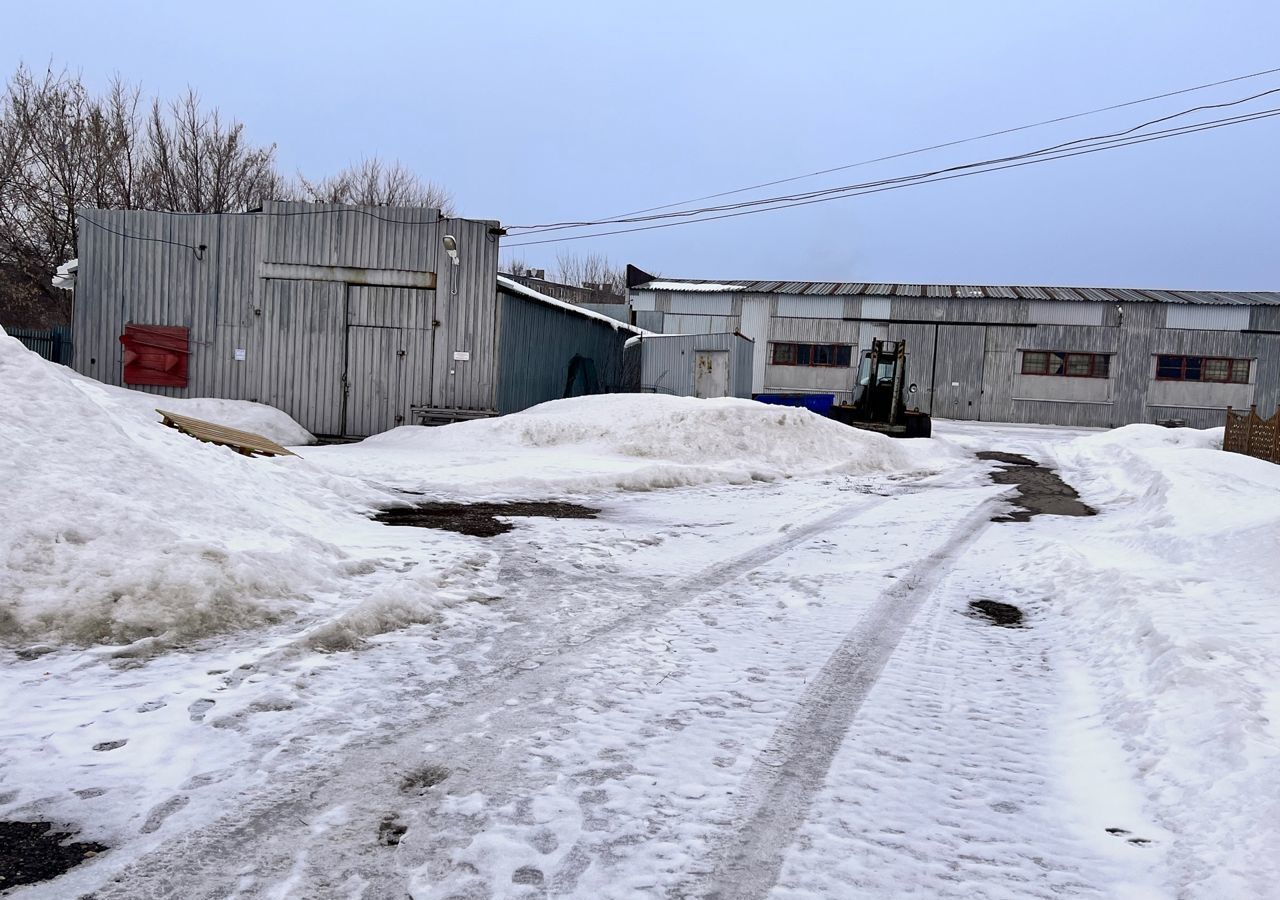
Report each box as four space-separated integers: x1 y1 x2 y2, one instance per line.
627 266 1280 306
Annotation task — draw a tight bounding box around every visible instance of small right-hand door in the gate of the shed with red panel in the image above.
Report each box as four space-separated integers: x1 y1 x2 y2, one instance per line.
343 325 406 438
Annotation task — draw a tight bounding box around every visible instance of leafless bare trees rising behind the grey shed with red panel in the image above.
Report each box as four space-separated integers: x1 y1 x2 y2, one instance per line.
0 65 454 330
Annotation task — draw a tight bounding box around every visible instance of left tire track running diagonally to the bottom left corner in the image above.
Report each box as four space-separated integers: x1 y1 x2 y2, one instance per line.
74 485 911 900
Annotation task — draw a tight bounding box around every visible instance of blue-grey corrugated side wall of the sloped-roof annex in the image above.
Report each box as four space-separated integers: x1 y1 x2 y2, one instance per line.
495 291 632 414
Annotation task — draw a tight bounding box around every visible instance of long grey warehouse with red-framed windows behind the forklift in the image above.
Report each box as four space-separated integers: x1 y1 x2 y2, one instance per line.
628 268 1280 428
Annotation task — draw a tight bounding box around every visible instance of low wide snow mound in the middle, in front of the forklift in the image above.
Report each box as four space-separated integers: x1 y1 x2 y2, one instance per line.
308 394 961 497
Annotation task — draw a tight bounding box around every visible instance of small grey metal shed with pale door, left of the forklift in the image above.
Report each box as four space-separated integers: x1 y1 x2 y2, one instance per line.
626 333 755 398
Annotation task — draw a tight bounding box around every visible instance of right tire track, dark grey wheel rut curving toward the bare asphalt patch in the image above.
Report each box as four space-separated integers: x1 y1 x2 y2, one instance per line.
677 501 995 900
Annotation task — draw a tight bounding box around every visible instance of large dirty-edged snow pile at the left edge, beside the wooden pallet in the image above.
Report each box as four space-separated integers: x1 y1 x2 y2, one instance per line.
0 333 385 643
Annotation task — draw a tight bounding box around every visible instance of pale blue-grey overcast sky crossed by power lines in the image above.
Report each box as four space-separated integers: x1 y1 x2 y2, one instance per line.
0 0 1280 289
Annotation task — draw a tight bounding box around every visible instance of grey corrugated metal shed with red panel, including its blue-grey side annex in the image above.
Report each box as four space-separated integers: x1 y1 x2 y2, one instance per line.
73 202 635 437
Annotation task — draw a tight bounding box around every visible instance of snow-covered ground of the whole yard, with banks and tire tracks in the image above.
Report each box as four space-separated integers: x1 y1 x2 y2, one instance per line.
0 338 1280 899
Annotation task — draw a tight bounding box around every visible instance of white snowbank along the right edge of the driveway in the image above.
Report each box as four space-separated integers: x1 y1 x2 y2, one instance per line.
1036 425 1280 896
